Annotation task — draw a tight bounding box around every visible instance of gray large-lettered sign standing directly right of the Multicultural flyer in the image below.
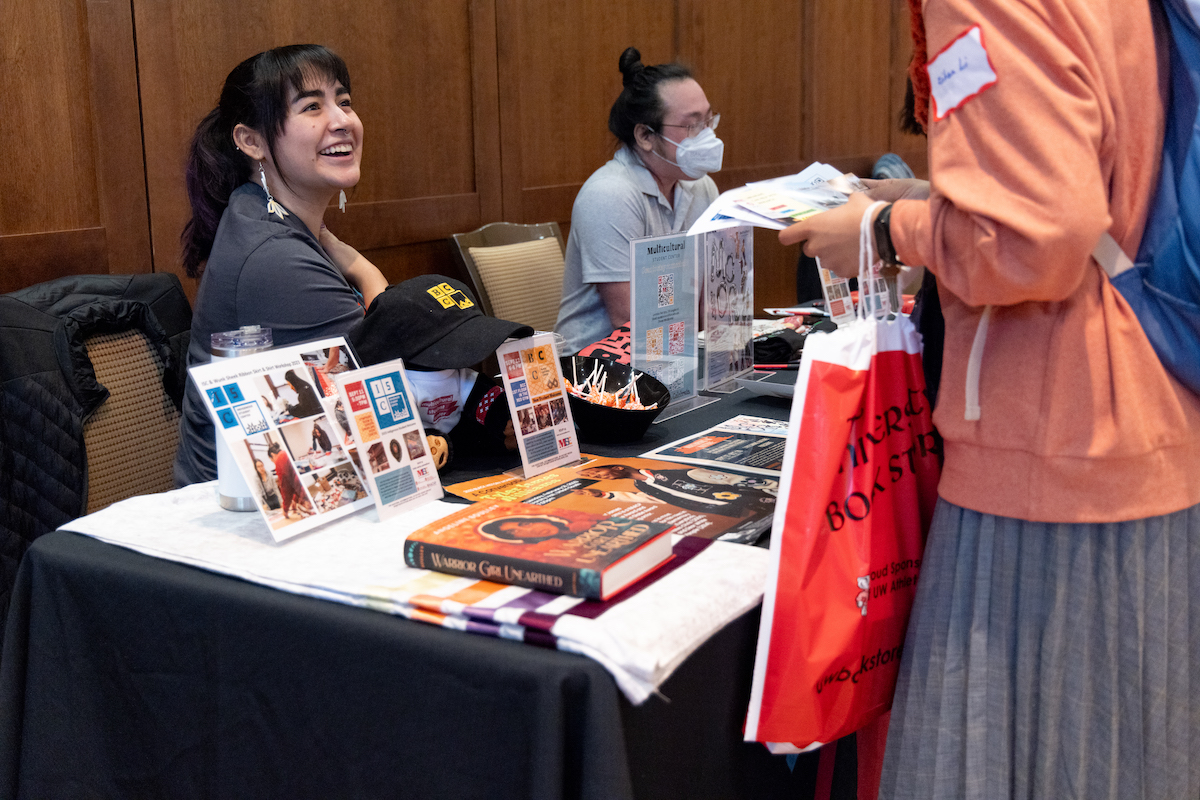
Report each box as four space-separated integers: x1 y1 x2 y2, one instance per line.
698 225 754 389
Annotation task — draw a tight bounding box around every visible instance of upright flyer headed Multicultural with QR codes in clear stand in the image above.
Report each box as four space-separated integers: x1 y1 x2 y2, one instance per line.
629 234 698 404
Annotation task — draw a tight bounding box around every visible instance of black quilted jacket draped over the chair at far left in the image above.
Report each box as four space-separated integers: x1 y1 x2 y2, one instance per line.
0 272 192 636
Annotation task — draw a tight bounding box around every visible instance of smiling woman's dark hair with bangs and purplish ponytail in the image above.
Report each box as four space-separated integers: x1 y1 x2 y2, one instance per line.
182 44 350 278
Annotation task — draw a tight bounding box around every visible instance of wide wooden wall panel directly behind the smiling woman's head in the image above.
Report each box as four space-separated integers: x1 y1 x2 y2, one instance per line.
134 0 499 297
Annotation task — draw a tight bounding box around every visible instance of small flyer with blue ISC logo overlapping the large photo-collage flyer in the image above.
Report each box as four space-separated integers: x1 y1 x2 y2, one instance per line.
337 359 442 521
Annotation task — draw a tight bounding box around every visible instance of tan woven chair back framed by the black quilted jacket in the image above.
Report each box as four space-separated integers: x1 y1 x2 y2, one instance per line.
83 329 180 513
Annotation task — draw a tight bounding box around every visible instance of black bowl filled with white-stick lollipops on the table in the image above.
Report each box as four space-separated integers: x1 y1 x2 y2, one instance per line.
559 355 671 444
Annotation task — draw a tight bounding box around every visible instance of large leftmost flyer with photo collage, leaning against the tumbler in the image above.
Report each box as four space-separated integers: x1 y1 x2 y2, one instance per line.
188 337 371 542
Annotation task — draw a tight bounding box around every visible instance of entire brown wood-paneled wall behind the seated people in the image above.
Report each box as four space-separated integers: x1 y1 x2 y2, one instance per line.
7 0 926 306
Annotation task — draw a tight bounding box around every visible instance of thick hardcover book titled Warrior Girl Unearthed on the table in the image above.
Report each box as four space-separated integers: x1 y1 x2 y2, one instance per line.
404 503 671 600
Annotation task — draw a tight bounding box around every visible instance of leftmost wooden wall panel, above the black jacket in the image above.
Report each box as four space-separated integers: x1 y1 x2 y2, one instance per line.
0 0 150 291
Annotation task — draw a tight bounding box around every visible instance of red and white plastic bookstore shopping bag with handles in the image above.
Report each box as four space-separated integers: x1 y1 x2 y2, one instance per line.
745 210 940 752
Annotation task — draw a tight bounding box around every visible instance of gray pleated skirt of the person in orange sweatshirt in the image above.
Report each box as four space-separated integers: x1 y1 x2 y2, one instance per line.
880 500 1200 800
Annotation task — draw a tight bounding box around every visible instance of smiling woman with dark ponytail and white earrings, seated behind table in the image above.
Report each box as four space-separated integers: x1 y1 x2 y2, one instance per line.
175 44 388 486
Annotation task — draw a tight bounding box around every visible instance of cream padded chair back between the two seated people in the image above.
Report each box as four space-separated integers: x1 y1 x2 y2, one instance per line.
450 222 564 331
